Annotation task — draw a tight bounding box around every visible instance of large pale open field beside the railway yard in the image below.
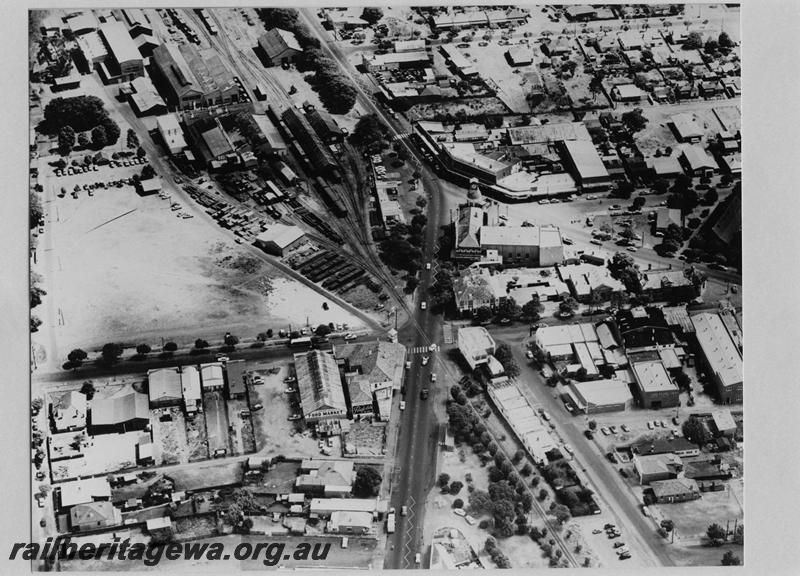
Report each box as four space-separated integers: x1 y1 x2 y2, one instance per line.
35 182 366 355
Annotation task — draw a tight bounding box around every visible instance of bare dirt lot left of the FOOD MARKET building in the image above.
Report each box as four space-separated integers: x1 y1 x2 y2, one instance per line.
250 365 320 458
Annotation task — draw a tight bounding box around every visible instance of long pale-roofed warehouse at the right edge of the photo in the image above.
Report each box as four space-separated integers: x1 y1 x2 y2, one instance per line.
692 312 744 404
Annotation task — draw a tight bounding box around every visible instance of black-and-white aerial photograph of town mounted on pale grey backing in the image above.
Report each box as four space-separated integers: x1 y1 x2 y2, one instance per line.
28 4 749 572
